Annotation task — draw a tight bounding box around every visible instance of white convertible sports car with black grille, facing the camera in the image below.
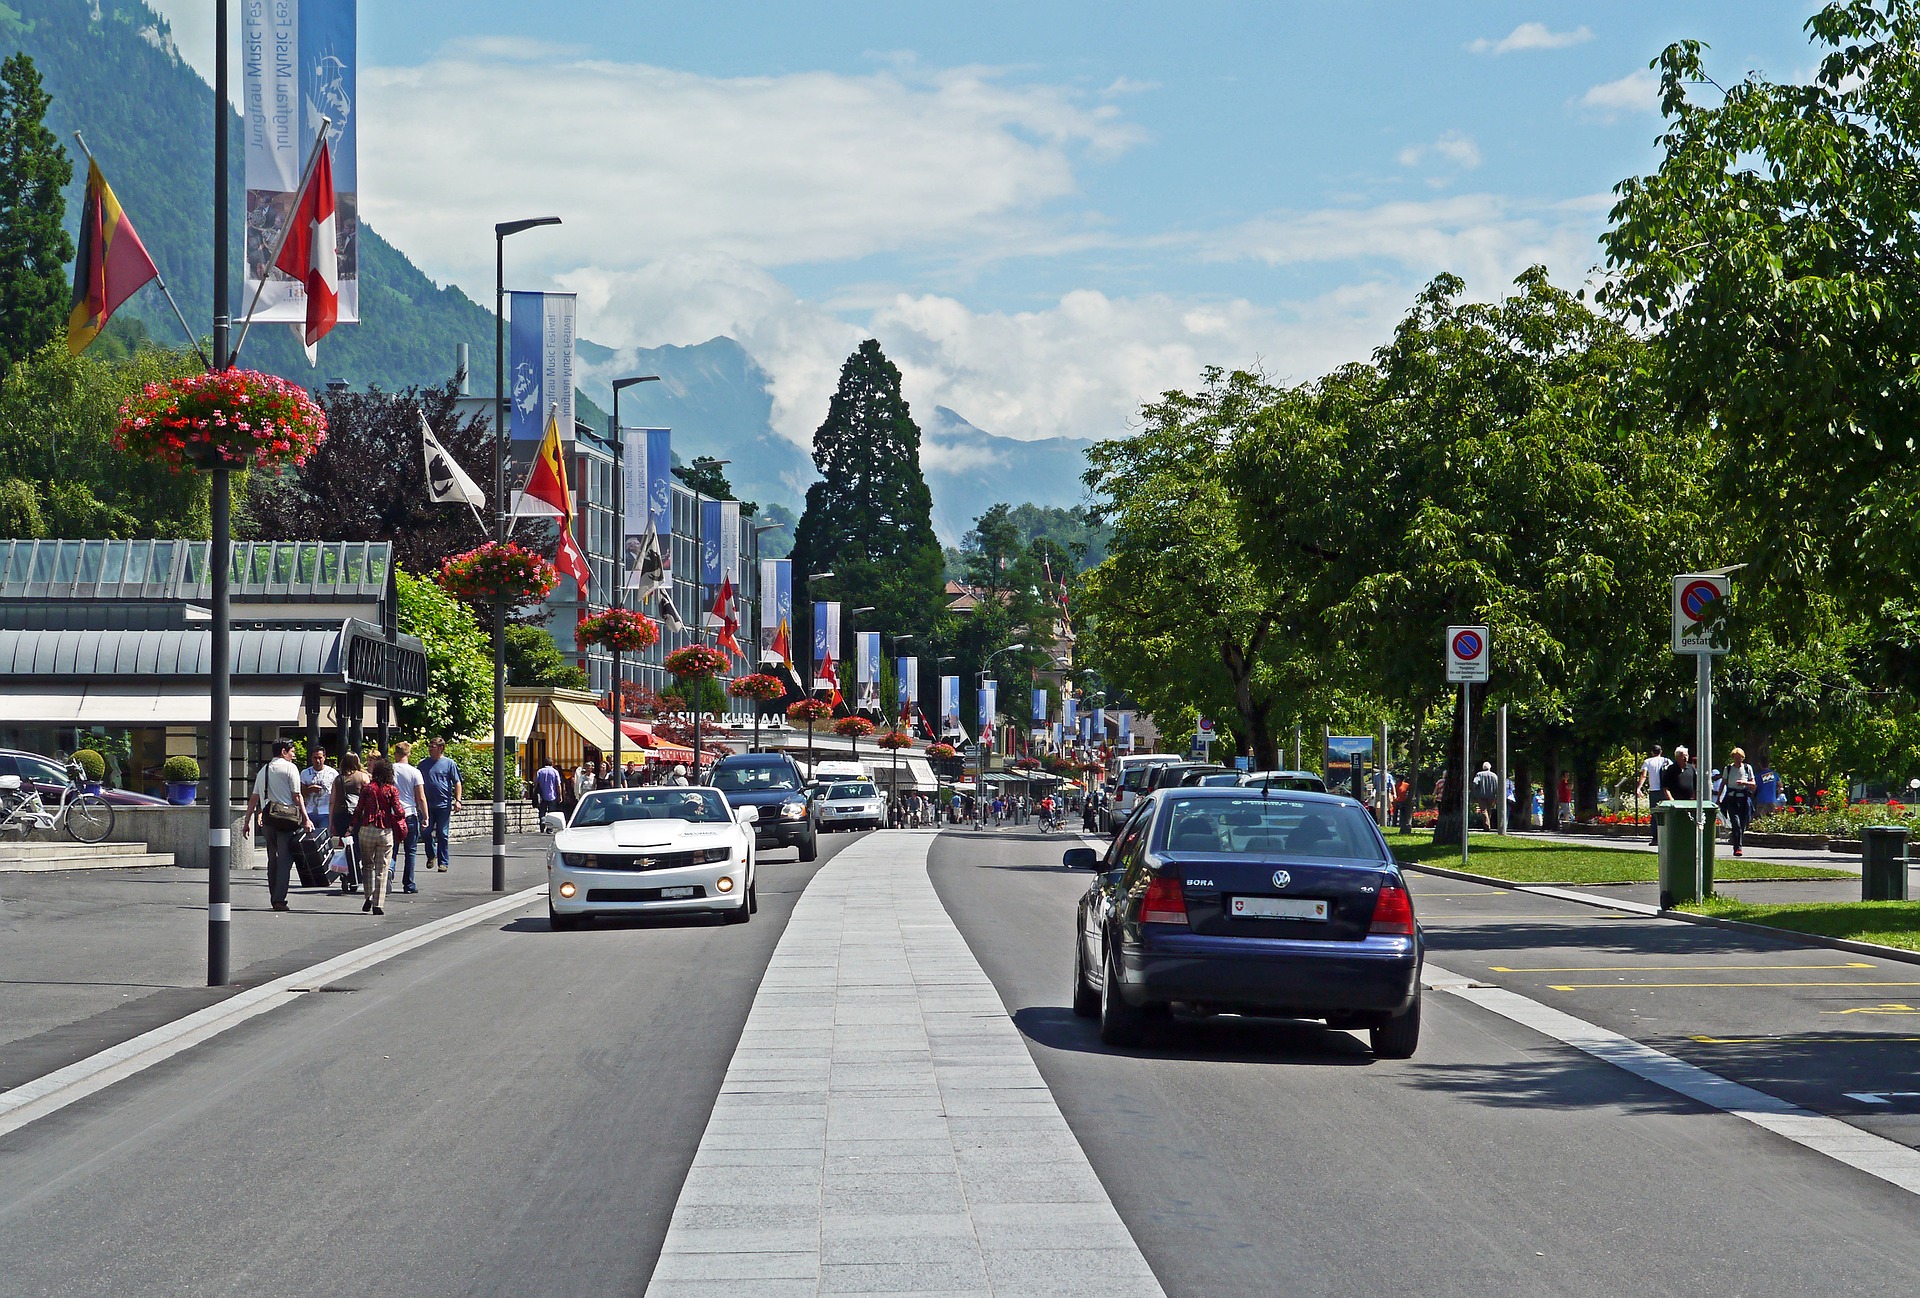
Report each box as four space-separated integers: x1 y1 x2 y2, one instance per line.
545 785 760 929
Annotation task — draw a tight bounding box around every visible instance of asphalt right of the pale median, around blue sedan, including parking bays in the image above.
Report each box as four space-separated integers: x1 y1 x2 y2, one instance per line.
931 833 1920 1298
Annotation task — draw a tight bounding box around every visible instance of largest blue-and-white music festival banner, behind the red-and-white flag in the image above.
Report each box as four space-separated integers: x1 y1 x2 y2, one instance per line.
243 0 360 326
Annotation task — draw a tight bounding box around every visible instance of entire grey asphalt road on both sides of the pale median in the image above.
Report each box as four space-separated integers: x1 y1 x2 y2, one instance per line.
0 829 1920 1298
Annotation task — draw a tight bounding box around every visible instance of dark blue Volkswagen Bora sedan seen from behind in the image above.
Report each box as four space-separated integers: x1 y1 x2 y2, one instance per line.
1066 787 1421 1060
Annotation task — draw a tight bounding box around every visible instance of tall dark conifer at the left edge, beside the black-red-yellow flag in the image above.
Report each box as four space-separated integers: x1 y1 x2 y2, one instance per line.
0 54 73 376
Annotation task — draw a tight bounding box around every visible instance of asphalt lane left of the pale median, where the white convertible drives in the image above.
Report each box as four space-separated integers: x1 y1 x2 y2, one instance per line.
0 835 856 1298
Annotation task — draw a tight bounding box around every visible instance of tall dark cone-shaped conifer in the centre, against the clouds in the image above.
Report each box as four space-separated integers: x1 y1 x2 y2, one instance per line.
793 338 945 649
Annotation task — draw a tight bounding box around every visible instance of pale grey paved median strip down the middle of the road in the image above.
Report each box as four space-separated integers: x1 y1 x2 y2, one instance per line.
647 829 1162 1298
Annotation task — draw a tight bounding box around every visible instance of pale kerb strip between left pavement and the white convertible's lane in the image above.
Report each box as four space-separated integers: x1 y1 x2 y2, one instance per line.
0 883 547 1137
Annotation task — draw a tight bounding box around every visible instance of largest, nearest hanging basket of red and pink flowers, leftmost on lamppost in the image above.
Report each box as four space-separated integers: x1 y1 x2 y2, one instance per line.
113 369 326 472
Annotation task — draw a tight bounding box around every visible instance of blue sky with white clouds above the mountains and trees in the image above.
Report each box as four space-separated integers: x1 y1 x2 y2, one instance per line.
145 0 1814 440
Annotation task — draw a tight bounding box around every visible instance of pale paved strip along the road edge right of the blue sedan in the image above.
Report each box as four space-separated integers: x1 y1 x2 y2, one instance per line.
1421 964 1920 1194
